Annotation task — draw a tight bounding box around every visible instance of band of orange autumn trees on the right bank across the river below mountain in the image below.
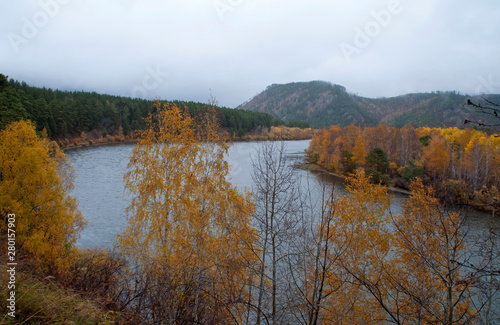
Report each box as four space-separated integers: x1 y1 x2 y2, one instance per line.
308 123 500 202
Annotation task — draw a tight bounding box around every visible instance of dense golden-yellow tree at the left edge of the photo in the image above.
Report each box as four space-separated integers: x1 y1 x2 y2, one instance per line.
0 121 86 271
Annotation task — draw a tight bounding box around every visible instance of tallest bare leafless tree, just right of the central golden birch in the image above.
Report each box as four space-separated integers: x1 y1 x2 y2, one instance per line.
252 141 299 324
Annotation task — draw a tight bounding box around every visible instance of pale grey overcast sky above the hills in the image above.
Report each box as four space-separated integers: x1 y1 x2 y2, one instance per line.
0 0 500 107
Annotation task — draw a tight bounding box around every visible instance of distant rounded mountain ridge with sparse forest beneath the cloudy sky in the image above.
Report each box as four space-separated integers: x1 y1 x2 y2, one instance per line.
238 81 500 128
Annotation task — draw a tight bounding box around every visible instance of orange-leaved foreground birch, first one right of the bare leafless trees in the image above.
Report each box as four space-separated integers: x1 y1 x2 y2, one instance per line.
319 169 391 324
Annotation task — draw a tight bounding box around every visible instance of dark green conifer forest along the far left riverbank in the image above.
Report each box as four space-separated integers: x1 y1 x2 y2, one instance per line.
0 74 307 138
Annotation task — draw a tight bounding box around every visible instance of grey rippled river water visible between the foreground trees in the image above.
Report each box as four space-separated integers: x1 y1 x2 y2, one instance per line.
66 140 500 248
